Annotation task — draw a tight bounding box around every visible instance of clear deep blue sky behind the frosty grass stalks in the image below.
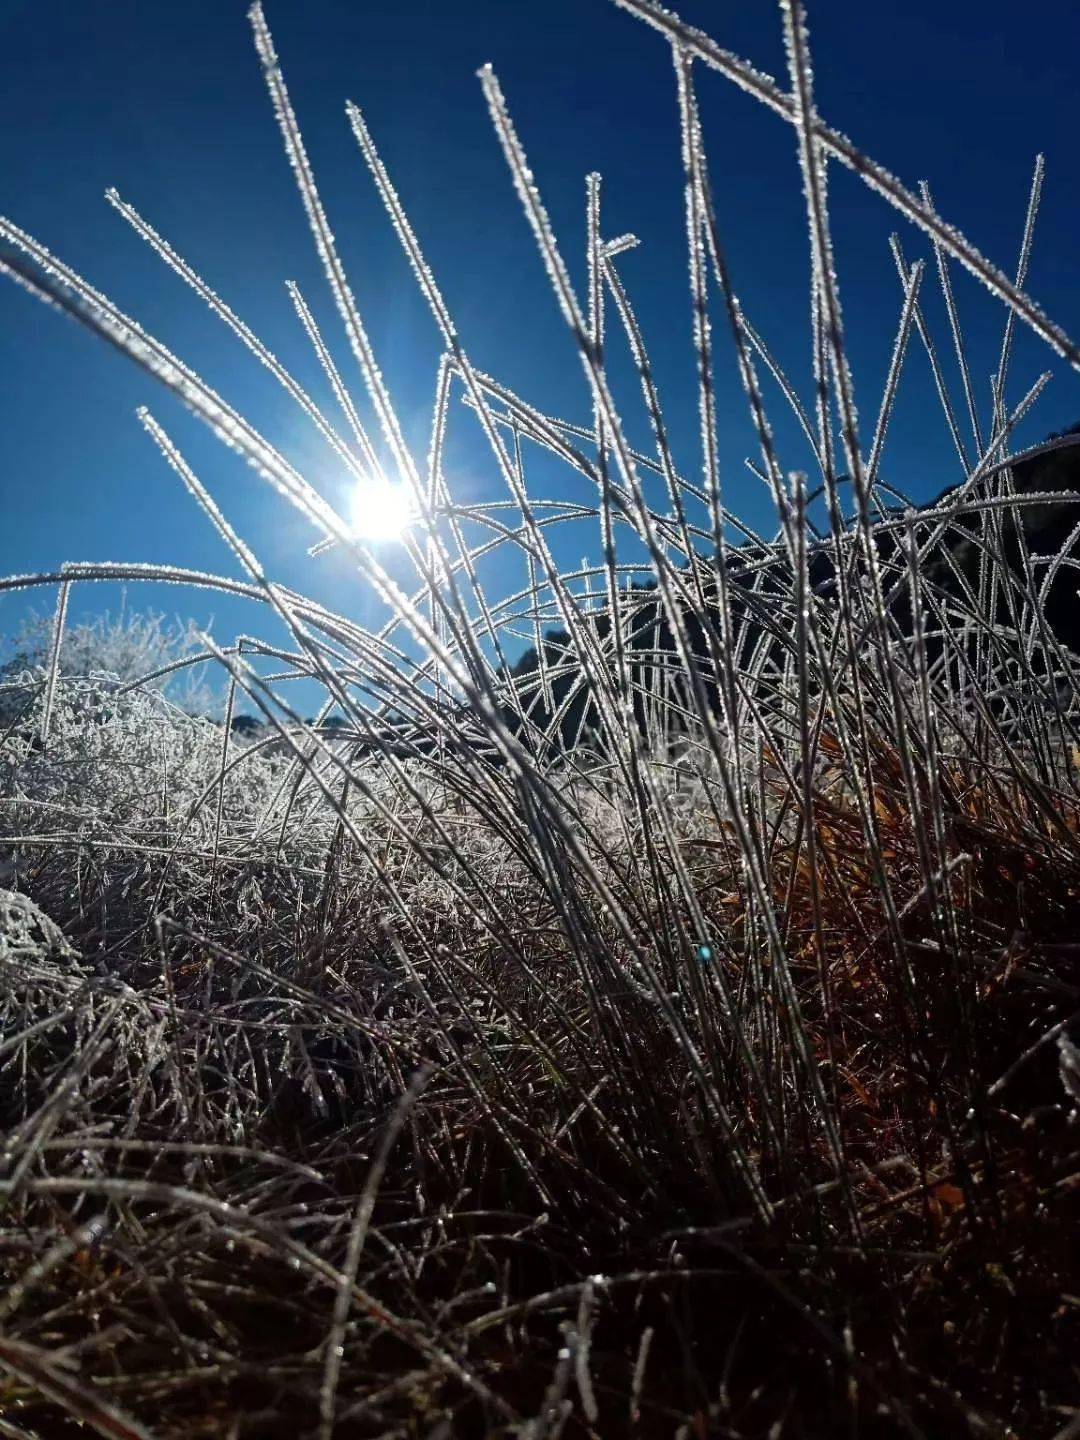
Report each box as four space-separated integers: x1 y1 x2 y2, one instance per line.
0 0 1080 679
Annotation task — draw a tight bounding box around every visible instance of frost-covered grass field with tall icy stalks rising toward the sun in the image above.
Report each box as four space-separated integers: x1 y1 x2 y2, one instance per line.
0 0 1080 1440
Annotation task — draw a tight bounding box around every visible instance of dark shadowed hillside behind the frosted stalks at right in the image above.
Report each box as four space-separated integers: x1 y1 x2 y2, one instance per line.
489 428 1080 746
